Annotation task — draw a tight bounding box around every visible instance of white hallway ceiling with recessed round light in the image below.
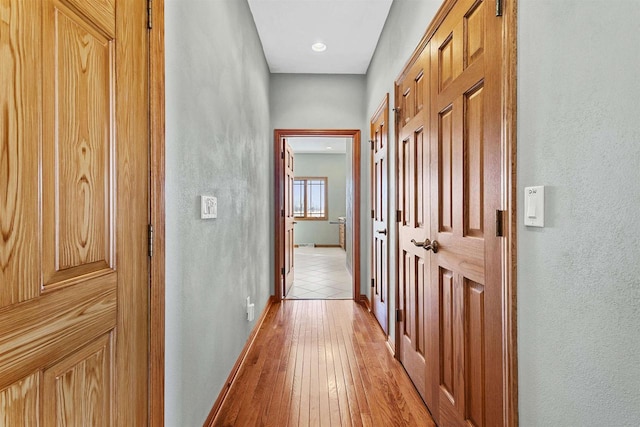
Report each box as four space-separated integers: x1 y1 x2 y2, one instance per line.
249 0 393 74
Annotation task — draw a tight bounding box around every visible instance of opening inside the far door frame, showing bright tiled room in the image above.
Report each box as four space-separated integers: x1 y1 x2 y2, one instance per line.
284 136 353 299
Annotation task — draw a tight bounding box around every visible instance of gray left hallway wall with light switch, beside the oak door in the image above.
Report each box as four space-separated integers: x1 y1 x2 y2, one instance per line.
165 0 273 426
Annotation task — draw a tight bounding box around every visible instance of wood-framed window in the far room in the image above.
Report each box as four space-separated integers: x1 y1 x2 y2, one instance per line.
293 177 329 220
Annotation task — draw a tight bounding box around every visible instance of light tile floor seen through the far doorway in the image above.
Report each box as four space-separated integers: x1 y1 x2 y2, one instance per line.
286 247 353 299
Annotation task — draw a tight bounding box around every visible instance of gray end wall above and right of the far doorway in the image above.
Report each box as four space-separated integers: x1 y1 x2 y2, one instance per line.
270 74 371 293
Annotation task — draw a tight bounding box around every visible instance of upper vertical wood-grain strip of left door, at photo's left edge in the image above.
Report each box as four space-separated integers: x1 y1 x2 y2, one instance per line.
0 0 42 308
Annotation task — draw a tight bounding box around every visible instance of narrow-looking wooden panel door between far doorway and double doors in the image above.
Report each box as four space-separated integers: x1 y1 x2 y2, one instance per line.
370 94 390 334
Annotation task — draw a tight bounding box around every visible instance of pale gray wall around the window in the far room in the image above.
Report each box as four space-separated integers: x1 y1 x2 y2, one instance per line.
294 153 347 245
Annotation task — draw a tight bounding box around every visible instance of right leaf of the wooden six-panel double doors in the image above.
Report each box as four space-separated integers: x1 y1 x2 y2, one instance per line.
429 0 503 427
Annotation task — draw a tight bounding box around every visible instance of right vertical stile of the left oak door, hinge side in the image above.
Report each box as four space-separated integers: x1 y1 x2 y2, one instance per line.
115 1 149 426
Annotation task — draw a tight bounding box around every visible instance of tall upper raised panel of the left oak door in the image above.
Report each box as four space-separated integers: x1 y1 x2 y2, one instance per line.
42 1 115 289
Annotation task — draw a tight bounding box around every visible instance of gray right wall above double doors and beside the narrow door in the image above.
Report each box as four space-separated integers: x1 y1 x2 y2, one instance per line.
364 0 442 342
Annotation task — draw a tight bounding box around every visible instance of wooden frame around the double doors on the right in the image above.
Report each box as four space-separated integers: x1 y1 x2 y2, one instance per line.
394 0 518 427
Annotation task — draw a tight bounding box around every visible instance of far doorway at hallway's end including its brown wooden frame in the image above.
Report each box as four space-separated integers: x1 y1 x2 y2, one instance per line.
274 129 360 300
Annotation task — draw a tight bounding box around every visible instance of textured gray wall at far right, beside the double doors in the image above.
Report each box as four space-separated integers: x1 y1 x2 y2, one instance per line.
518 0 640 427
